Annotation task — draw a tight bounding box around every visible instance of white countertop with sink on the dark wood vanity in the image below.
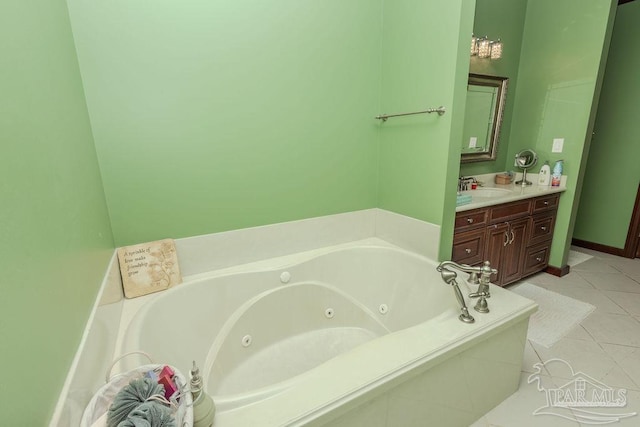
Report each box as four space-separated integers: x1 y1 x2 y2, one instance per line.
456 174 567 212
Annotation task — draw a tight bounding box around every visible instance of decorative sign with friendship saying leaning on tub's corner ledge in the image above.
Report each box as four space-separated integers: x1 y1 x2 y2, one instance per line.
118 239 182 298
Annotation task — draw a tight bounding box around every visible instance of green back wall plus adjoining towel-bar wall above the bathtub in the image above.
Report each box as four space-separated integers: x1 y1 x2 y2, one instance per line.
69 0 474 249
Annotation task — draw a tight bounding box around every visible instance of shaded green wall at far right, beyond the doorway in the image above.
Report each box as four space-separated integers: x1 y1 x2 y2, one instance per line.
573 1 640 249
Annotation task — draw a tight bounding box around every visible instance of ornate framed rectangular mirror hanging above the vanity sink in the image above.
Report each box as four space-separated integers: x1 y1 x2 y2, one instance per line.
460 74 509 163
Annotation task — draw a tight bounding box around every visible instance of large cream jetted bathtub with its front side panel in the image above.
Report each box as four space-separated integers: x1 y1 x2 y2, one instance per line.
118 238 536 427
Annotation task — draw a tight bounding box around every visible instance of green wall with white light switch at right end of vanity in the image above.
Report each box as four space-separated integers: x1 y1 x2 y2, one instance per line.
507 0 616 267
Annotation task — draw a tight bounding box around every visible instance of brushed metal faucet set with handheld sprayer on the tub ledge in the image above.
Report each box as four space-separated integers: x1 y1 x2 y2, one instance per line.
436 261 498 323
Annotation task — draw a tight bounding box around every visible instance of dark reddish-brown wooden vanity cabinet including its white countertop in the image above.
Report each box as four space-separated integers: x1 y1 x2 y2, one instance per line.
452 184 565 286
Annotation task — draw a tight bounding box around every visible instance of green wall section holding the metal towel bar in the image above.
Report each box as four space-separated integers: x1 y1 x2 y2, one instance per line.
379 0 474 247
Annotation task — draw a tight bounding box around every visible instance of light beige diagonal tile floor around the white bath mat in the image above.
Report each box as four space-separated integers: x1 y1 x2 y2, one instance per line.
472 247 640 427
